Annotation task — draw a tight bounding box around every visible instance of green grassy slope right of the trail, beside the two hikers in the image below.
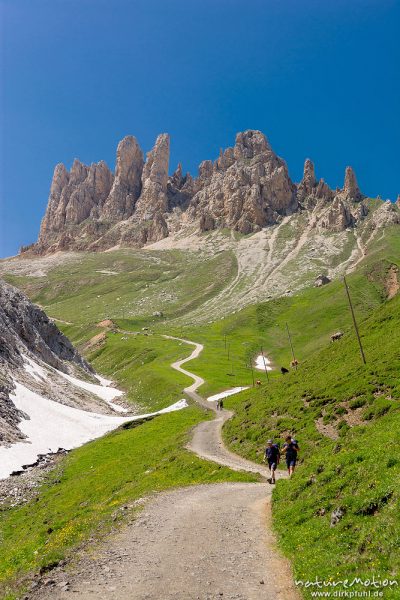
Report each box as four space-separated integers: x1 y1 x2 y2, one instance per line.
225 296 400 598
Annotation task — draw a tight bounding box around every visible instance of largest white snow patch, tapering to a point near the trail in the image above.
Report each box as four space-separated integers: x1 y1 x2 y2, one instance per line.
0 382 187 479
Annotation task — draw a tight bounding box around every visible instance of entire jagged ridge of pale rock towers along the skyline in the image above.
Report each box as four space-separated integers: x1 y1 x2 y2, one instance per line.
27 130 388 253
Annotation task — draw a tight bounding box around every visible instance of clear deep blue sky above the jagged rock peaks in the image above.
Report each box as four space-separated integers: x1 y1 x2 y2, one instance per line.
0 0 400 256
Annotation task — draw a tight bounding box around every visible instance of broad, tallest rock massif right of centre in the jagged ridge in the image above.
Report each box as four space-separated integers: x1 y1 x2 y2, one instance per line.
187 131 297 234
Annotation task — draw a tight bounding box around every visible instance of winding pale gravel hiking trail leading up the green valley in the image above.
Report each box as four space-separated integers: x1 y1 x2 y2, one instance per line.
28 336 300 600
